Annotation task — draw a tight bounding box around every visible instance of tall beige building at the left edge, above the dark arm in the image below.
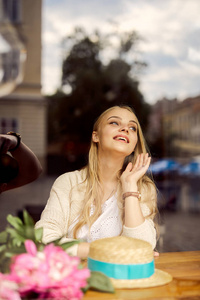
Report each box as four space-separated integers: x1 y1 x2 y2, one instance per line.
0 0 47 168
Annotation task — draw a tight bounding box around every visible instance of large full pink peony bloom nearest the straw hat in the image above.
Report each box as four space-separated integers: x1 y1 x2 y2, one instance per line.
7 240 90 300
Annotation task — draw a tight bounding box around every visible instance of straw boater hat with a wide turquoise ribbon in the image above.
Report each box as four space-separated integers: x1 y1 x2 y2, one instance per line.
88 236 172 288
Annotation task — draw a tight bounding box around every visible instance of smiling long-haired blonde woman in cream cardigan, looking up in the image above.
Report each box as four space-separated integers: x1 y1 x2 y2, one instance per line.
36 106 157 258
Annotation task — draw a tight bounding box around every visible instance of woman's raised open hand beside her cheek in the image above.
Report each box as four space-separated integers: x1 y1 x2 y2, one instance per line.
121 153 151 192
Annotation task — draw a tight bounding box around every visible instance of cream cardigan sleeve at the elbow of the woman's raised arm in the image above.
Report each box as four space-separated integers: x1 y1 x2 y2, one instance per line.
122 203 156 249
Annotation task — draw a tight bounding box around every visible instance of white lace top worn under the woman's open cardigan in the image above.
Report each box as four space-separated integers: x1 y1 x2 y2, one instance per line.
67 194 122 242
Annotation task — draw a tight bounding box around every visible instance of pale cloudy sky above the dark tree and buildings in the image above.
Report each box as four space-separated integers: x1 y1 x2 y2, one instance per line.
42 0 200 103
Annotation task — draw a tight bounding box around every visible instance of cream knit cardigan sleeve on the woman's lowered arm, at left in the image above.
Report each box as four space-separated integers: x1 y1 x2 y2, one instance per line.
35 171 84 256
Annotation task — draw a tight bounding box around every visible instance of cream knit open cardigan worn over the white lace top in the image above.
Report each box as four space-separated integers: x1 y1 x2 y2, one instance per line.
35 169 156 255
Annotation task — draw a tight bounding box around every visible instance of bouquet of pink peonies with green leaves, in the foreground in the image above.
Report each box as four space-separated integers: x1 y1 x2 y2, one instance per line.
0 211 114 300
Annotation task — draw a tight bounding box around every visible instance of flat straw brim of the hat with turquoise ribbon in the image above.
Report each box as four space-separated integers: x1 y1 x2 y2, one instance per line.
110 269 172 289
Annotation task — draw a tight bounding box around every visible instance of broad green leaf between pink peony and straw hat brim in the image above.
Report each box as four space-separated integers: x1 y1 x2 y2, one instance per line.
87 271 115 293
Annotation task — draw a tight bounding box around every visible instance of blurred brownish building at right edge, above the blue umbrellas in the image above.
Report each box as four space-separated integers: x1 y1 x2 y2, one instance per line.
150 96 200 159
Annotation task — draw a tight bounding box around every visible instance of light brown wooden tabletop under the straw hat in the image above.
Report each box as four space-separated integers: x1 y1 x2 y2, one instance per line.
83 251 200 300
